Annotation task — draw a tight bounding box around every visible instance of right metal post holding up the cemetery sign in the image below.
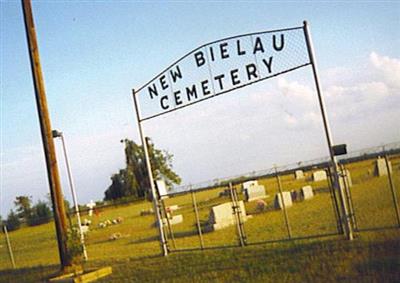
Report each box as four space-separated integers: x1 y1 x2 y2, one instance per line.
303 21 353 240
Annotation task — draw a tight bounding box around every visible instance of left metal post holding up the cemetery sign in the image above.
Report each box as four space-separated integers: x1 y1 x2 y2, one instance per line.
132 89 168 256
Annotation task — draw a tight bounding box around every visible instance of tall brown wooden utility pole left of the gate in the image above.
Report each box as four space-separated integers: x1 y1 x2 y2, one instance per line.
22 0 71 270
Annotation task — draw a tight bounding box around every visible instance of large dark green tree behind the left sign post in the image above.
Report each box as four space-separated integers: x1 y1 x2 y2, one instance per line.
104 139 181 200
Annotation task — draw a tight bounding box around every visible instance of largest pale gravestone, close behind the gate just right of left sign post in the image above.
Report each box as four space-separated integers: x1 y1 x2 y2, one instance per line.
208 201 247 231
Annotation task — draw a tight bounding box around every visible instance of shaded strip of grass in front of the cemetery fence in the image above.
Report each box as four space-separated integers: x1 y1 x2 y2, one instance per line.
0 230 400 282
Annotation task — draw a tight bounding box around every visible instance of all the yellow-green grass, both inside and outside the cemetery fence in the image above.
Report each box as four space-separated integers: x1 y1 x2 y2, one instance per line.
0 156 400 282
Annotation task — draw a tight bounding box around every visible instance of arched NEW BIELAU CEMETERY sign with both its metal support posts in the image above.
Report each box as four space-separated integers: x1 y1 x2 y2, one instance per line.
132 22 352 255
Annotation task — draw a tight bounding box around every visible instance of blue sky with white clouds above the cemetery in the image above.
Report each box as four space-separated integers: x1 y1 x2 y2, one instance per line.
0 1 400 216
